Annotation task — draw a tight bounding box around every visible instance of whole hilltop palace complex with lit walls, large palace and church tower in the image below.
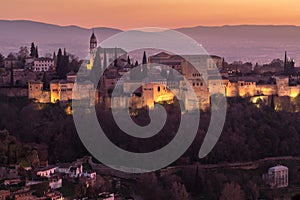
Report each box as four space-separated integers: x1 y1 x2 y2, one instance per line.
28 33 300 110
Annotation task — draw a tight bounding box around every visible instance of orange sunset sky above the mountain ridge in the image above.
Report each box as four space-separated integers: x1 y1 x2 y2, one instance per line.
0 0 300 30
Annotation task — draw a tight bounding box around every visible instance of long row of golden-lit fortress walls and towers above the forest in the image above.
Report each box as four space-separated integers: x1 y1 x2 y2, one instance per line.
28 72 300 110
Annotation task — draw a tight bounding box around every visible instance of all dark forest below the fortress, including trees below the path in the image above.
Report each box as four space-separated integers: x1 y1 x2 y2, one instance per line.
0 97 300 200
